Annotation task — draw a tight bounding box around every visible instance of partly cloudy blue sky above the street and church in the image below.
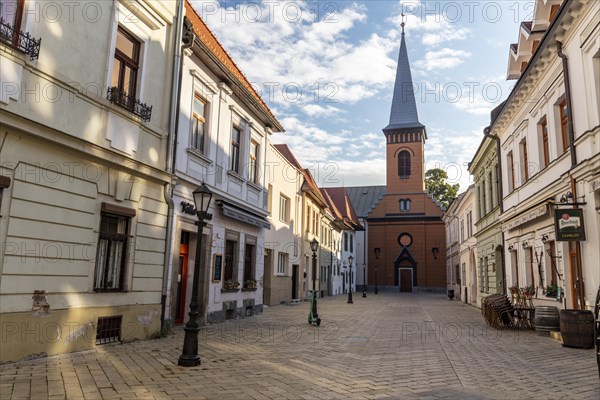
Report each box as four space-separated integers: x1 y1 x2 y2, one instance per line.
192 0 534 190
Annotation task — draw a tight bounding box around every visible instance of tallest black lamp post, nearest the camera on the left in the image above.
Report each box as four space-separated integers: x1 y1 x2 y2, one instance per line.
178 182 212 367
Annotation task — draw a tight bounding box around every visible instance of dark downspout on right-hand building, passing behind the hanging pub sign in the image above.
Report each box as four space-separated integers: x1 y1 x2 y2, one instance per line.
556 40 585 310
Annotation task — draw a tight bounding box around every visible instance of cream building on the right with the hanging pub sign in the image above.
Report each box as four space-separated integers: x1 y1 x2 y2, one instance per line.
490 0 600 309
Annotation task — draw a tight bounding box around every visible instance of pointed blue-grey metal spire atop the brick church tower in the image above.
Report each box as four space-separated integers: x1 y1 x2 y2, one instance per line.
383 14 424 133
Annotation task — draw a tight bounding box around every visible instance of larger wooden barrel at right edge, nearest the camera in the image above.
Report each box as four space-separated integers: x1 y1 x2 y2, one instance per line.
560 310 594 349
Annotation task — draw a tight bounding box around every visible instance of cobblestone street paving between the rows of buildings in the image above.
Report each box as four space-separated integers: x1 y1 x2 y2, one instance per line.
0 293 600 399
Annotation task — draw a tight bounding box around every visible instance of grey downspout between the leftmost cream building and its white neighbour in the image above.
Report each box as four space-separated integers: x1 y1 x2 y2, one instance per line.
160 0 185 332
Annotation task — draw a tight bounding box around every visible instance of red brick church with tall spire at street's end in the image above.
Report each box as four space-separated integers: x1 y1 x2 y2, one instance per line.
346 23 446 292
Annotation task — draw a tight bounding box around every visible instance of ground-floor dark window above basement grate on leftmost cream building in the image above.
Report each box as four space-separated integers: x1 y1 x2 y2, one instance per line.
94 213 131 291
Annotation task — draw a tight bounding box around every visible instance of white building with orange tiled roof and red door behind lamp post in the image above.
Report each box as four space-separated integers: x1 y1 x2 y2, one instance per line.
167 2 283 323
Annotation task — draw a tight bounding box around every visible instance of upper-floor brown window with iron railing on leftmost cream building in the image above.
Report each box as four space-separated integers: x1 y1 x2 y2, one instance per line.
112 27 140 98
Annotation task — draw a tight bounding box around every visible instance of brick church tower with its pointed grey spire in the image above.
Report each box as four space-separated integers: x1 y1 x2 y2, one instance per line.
383 22 427 193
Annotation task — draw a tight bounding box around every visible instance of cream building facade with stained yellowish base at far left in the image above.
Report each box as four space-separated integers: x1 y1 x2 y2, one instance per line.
0 1 181 361
